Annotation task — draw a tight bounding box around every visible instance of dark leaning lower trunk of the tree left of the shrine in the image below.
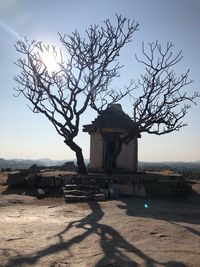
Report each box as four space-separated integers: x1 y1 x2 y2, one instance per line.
64 140 87 173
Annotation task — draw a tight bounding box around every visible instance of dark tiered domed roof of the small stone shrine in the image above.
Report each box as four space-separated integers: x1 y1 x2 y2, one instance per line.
83 104 134 132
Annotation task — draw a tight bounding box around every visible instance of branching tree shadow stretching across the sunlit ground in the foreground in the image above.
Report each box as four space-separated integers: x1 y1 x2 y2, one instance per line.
5 199 189 267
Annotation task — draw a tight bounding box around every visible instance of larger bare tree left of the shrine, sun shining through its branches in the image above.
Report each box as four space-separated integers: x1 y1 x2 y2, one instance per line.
15 16 138 173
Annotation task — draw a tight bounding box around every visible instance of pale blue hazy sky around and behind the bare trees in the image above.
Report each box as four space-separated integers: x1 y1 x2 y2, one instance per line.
0 0 200 161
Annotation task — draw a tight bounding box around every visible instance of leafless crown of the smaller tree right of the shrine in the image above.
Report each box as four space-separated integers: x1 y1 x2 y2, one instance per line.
132 42 199 138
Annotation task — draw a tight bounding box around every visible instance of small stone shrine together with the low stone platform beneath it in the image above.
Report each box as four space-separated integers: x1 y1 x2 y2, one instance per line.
6 104 192 202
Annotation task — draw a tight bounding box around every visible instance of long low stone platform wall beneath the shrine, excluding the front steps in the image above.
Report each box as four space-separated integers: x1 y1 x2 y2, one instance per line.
7 172 191 197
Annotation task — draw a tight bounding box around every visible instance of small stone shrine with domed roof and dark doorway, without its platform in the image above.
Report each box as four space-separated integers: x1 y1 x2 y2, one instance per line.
83 104 139 173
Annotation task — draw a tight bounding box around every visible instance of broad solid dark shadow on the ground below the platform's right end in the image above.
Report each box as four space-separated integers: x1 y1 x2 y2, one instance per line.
118 192 200 241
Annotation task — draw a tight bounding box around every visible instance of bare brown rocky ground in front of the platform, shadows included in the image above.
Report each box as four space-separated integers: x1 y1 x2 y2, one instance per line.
0 174 200 267
